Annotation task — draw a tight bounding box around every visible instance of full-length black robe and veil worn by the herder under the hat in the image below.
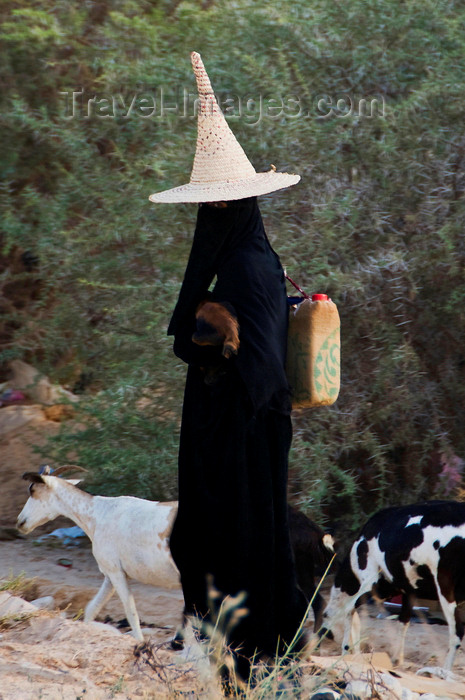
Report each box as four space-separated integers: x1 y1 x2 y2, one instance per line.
168 198 306 676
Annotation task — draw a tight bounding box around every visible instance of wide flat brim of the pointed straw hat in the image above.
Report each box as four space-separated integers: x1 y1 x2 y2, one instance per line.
149 170 300 203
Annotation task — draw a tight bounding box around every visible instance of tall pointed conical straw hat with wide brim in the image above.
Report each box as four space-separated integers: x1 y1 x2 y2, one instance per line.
149 51 300 202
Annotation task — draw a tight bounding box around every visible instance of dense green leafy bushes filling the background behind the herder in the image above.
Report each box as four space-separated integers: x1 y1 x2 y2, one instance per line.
0 0 465 529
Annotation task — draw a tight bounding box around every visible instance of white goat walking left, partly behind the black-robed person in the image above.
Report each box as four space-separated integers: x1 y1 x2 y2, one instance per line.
17 465 179 641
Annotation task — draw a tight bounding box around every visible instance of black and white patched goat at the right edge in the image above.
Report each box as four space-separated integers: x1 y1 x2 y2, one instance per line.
323 501 465 671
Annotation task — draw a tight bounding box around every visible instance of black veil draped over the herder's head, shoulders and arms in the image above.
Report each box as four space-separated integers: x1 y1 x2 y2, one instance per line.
168 197 290 413
